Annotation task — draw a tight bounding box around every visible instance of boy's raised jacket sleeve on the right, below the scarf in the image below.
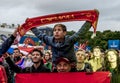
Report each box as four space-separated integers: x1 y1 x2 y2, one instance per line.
71 21 92 43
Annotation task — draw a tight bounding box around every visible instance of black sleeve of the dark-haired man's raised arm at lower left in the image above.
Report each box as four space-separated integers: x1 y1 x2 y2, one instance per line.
6 57 23 73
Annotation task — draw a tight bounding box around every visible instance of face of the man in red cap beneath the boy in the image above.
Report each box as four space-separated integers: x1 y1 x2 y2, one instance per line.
57 61 71 72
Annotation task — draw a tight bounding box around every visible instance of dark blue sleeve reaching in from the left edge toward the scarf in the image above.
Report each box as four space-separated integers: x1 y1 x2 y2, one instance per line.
0 35 15 57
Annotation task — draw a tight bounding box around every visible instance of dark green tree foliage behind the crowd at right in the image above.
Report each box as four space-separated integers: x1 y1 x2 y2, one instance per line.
68 30 120 50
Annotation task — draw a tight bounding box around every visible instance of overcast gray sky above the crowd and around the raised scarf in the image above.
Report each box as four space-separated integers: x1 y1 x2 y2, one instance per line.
0 0 120 31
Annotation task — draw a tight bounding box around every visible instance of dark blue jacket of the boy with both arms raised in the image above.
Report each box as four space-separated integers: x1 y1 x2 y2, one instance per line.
31 22 91 63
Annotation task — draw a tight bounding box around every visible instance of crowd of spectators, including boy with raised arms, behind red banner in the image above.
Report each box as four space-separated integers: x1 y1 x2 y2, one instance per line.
0 22 120 83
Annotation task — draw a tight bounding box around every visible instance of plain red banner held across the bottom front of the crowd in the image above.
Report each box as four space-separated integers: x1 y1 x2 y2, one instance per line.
15 72 110 83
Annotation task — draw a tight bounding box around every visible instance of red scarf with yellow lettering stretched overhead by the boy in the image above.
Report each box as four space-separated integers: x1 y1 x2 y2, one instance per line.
19 9 99 36
